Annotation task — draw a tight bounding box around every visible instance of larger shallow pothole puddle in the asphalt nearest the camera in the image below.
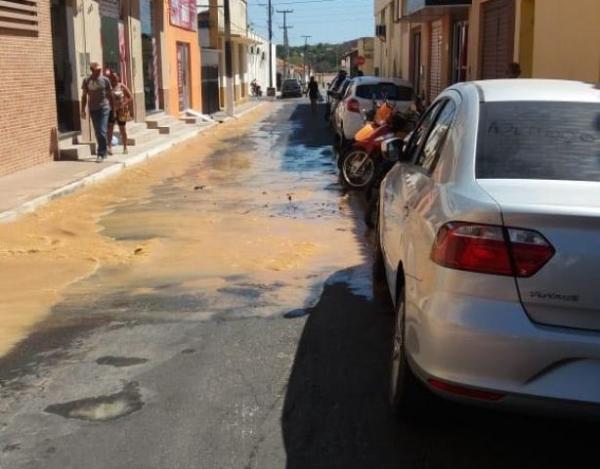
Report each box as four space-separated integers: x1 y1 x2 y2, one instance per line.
44 381 144 422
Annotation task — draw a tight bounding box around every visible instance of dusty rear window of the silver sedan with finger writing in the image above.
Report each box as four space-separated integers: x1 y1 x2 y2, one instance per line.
476 101 600 182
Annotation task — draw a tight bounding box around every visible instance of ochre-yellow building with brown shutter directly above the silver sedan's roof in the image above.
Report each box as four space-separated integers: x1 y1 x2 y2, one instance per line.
468 0 600 83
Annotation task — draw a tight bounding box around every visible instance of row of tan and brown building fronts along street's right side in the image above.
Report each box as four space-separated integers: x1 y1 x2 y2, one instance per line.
374 0 600 102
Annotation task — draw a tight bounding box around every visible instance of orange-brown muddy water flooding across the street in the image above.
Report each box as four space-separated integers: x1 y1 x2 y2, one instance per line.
0 103 368 354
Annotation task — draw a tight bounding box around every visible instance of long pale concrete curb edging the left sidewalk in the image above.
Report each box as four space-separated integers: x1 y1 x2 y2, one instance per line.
0 102 264 224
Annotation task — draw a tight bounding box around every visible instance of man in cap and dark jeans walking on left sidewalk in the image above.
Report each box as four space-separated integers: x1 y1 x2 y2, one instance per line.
81 62 112 161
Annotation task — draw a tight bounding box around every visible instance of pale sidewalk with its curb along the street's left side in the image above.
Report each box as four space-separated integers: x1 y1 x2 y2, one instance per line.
0 100 262 223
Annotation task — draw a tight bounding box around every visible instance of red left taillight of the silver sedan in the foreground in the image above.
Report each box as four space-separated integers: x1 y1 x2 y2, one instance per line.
431 223 555 277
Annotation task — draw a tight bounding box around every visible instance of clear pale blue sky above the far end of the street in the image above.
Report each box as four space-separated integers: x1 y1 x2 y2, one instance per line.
247 0 374 46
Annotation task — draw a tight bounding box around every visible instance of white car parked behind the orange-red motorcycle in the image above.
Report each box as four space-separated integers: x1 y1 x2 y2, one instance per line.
334 77 414 144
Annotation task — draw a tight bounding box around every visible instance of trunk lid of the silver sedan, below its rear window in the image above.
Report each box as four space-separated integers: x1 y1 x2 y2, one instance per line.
478 179 600 330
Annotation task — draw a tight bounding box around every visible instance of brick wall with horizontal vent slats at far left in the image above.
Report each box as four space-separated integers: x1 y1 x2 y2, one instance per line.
0 0 57 176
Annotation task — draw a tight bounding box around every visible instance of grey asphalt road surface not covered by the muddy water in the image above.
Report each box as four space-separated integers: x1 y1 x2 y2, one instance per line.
0 100 598 469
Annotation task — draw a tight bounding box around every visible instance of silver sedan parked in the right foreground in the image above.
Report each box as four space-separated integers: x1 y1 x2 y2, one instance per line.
377 80 600 415
